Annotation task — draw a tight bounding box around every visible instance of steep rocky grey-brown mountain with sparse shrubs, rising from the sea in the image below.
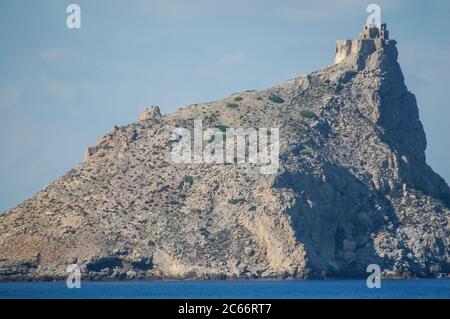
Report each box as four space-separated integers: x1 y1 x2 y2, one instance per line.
0 29 450 280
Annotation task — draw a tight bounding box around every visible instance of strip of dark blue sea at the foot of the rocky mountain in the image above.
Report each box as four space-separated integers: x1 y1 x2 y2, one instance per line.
0 279 450 299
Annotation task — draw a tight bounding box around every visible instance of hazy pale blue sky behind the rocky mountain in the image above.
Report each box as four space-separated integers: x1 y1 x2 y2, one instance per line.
0 0 450 211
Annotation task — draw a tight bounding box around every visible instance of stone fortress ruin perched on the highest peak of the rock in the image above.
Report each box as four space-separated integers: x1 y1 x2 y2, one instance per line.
334 23 395 63
